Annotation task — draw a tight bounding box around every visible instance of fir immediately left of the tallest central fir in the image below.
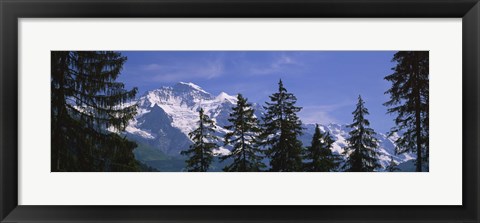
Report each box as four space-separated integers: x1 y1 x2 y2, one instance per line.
221 94 265 172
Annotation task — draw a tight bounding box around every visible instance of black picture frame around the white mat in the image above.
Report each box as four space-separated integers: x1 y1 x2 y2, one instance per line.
0 0 480 222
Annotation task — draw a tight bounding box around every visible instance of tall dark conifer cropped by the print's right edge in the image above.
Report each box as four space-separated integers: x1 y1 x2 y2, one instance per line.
384 51 429 172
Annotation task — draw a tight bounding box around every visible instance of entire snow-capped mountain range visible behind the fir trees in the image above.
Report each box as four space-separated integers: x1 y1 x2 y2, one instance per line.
126 82 414 171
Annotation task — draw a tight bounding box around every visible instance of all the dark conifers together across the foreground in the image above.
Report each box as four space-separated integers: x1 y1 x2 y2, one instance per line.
51 51 429 172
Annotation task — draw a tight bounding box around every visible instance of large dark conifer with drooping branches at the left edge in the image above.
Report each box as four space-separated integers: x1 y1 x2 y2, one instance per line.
51 51 137 172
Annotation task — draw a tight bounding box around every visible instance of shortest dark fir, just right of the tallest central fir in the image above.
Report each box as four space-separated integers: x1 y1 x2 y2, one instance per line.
304 124 339 172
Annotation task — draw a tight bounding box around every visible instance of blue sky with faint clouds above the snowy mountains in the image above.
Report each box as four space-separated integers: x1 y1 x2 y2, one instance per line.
118 51 395 133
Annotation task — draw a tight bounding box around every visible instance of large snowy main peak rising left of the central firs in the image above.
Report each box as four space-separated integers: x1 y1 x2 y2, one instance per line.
126 82 242 156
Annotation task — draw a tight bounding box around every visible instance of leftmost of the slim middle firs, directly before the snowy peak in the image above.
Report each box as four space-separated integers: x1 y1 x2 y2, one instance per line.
181 108 218 172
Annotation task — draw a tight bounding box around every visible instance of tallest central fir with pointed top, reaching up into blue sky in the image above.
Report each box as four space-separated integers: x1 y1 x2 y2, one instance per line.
262 80 302 172
